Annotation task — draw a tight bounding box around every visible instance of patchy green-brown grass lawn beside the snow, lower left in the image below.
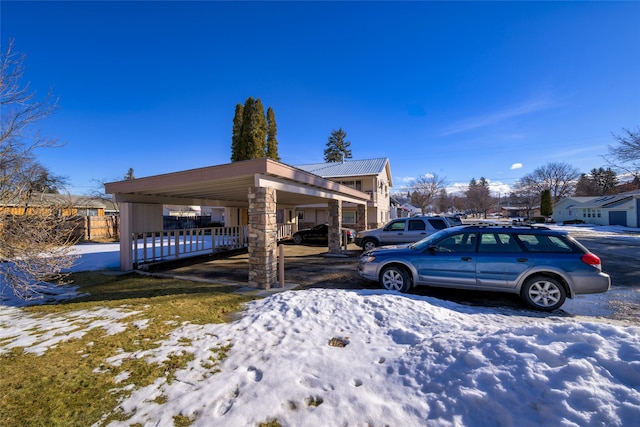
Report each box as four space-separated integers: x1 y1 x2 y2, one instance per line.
0 273 252 427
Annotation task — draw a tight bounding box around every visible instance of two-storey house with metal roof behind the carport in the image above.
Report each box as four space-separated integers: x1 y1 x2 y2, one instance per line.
295 158 393 230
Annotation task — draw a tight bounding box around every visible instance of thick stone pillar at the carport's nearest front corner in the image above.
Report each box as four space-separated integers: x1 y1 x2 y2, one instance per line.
249 187 278 289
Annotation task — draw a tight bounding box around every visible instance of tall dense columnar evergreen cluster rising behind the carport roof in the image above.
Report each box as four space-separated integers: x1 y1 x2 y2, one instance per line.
231 97 280 162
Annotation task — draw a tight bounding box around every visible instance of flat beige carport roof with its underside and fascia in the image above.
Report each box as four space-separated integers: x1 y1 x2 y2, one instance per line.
105 159 369 207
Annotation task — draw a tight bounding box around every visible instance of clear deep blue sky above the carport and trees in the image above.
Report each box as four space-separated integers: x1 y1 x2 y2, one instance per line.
0 0 640 193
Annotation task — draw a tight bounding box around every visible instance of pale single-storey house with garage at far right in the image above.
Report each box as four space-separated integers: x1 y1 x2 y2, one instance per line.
552 190 640 228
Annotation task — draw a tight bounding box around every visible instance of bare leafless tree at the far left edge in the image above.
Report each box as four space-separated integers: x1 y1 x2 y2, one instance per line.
0 41 77 298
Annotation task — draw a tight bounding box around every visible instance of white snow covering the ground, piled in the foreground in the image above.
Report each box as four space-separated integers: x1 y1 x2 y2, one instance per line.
0 227 640 427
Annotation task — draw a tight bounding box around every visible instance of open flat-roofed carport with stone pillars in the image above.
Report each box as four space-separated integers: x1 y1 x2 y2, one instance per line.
105 158 370 289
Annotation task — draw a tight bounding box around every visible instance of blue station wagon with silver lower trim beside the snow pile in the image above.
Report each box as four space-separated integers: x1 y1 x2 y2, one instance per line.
358 226 611 311
